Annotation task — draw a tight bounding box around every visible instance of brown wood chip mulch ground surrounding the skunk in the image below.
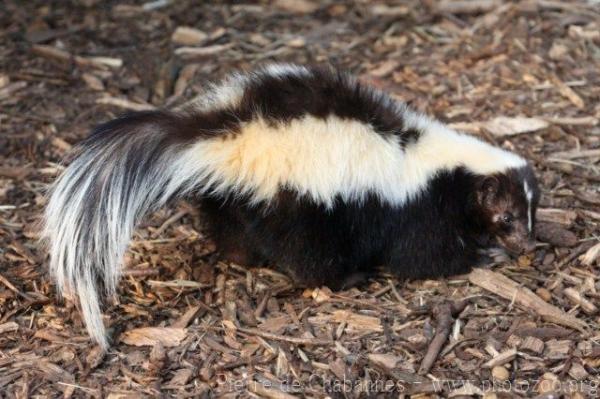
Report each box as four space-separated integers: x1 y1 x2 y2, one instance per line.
0 0 600 399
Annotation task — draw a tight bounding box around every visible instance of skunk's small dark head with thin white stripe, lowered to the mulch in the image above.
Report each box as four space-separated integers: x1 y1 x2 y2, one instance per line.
475 165 540 255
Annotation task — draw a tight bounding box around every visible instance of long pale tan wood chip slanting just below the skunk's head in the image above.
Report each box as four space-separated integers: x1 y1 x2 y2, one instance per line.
469 268 587 332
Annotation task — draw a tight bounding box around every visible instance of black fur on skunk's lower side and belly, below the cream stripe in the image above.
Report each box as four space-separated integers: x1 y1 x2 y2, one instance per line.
202 168 485 288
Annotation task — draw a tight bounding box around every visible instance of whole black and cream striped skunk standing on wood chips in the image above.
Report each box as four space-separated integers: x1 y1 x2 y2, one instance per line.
43 65 539 348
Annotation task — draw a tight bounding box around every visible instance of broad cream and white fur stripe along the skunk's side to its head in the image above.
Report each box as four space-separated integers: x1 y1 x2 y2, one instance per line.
186 114 525 205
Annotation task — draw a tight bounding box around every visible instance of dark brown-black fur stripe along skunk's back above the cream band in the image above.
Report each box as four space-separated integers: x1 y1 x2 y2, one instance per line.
81 67 421 154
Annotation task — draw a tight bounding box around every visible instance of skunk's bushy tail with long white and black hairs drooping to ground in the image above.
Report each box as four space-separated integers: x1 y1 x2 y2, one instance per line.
43 111 210 348
